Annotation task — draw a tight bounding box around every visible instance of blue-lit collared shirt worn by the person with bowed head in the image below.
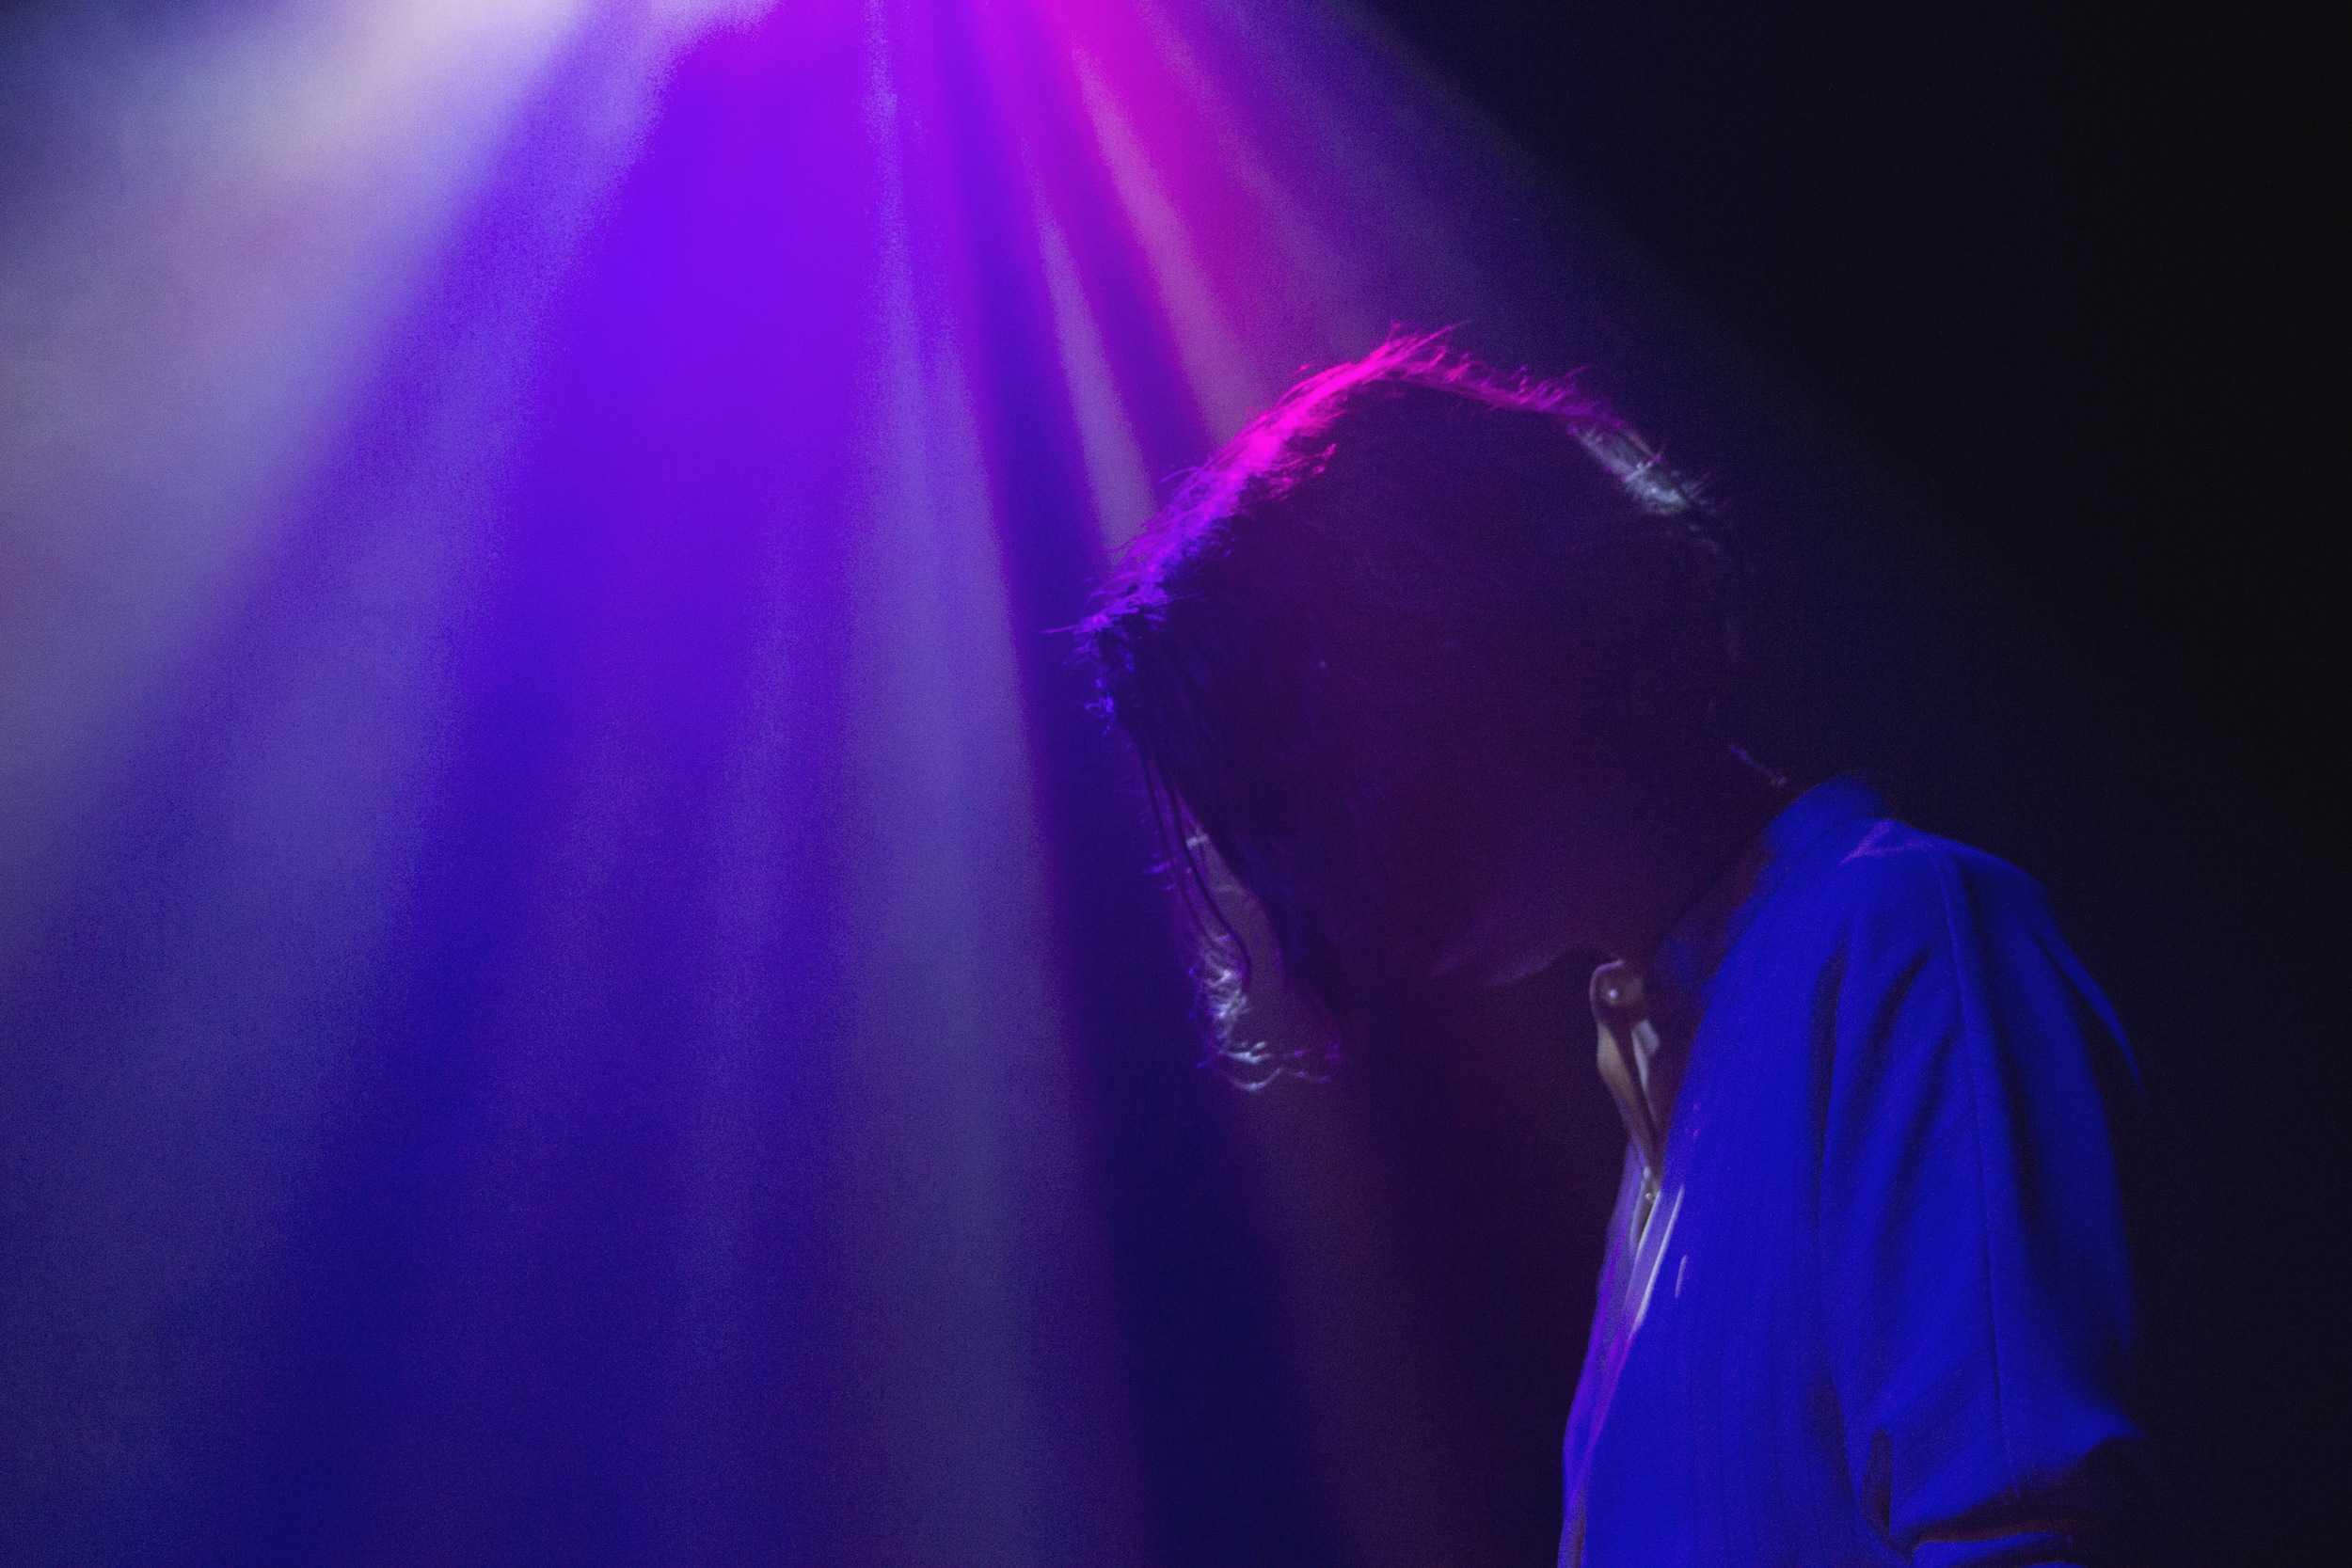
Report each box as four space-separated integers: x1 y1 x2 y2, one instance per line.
1560 778 2143 1568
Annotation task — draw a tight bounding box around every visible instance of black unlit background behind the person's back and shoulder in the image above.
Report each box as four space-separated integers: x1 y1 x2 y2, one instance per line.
1336 0 2347 1561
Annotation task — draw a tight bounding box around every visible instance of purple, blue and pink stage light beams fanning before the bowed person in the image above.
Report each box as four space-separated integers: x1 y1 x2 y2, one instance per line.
0 0 1731 1563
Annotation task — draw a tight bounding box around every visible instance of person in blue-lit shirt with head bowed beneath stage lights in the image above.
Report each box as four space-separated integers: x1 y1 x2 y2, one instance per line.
1080 336 2145 1568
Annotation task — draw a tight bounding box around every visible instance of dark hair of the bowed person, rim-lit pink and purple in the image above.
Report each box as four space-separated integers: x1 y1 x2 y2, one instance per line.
1080 334 1729 1079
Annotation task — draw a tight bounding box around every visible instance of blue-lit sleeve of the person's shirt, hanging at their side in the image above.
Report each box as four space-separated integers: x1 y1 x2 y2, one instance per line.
1816 842 2145 1568
